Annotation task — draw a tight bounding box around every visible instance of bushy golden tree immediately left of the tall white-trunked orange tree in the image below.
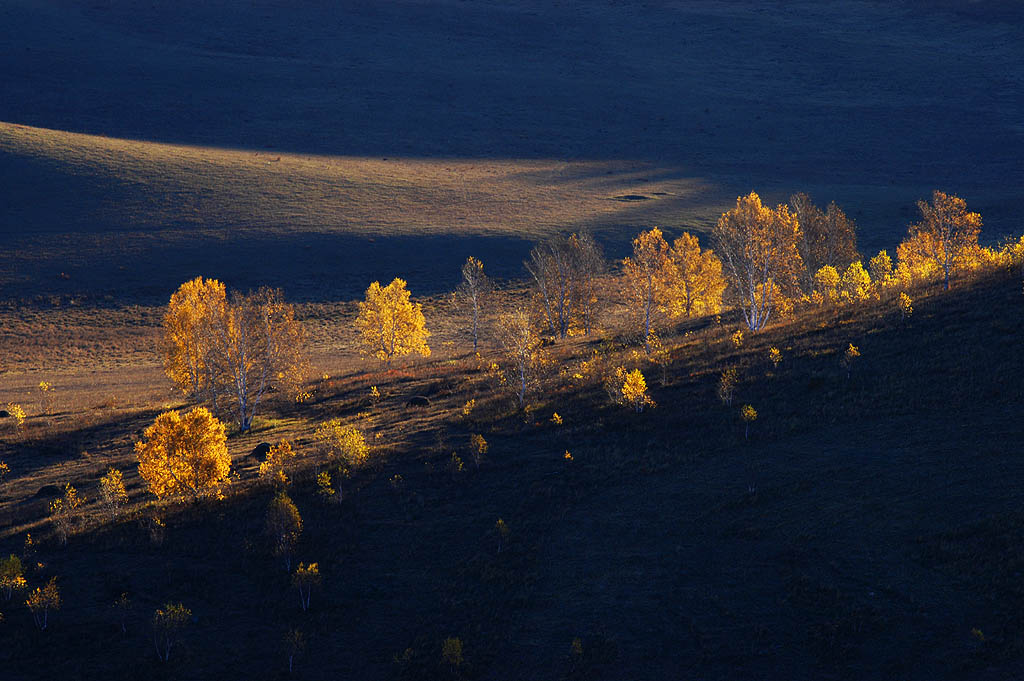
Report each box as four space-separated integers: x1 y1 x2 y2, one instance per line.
671 231 727 316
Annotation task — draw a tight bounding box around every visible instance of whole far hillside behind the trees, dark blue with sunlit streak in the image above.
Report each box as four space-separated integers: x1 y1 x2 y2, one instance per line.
0 0 1024 298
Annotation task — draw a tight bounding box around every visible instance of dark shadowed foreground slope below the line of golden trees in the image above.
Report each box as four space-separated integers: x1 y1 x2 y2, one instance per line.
2 268 1024 679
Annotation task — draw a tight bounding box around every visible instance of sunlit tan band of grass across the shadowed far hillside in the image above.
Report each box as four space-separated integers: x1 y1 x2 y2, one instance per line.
0 123 721 239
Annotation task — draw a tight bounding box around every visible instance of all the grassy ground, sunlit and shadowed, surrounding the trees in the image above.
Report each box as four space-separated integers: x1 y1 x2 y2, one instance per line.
0 0 1024 681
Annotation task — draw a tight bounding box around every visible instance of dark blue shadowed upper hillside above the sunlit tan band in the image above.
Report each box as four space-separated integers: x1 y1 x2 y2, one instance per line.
0 0 1024 187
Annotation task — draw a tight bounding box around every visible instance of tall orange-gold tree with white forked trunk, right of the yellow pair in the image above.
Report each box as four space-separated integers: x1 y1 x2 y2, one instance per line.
713 191 803 331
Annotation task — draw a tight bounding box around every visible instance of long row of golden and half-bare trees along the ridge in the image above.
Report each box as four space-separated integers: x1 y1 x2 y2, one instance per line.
164 191 1011 431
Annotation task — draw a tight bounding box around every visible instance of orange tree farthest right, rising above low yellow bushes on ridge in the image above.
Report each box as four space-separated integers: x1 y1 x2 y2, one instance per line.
905 189 981 291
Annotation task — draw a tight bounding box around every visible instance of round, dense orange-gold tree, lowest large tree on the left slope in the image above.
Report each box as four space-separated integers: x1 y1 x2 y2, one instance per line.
135 407 231 499
